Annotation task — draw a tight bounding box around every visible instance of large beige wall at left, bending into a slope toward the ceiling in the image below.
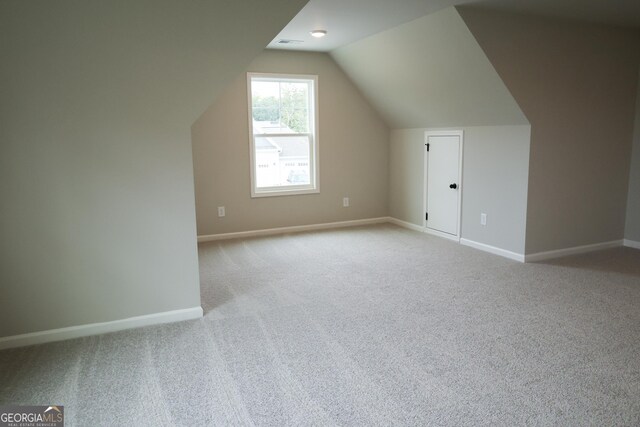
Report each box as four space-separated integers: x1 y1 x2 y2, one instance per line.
0 0 304 337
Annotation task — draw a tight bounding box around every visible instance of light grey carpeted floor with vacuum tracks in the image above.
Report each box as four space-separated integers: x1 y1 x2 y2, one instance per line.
0 225 640 426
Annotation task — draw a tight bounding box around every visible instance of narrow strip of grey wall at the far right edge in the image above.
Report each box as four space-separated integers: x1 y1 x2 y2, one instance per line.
624 70 640 243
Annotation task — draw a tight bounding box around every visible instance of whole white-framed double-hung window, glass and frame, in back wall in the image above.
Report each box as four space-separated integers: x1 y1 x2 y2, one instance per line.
247 73 319 197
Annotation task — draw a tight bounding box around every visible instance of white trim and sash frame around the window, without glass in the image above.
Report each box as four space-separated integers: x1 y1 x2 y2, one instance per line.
247 73 320 198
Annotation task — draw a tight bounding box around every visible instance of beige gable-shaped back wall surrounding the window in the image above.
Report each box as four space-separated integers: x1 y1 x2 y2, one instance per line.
192 51 389 235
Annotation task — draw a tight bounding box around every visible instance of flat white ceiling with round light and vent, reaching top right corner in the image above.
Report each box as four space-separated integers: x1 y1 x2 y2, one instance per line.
267 0 640 52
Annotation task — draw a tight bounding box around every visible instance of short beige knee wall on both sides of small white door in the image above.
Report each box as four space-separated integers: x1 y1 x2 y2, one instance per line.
389 125 530 255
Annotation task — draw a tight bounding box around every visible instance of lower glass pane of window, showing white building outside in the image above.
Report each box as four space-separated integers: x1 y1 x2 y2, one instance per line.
255 135 311 188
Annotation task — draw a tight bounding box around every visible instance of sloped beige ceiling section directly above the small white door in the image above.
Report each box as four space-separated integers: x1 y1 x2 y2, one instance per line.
331 7 528 129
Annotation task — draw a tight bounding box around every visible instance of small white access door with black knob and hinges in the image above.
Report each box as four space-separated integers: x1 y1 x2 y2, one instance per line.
425 131 462 239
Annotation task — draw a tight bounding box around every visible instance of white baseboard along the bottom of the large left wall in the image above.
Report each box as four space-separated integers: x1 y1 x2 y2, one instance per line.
0 307 203 350
